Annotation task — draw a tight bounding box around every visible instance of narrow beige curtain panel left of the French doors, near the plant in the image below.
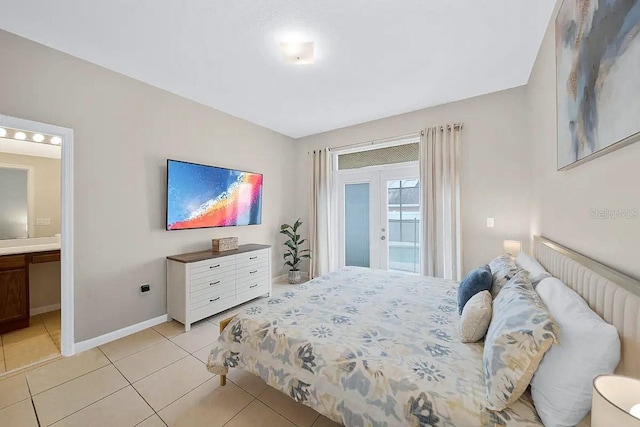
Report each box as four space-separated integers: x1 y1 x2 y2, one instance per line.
309 148 333 278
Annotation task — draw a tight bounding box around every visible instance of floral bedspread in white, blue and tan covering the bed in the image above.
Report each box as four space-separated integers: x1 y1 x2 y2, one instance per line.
207 267 542 427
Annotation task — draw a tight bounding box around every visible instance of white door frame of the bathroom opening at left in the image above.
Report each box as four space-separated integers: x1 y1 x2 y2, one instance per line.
0 114 75 356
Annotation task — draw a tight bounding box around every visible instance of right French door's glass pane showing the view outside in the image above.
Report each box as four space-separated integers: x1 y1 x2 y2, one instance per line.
387 179 420 273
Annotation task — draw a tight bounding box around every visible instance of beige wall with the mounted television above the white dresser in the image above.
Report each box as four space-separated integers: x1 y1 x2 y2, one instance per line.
0 32 294 341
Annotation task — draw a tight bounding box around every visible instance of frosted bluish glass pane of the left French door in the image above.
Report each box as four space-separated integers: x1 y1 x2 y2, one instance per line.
344 183 371 267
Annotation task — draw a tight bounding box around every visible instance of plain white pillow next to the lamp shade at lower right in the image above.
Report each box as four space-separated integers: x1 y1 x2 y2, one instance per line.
531 277 620 427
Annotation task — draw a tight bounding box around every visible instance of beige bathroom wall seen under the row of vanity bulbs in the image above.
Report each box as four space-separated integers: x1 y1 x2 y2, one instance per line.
0 152 60 237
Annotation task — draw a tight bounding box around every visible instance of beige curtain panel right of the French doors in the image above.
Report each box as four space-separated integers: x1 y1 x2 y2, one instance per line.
420 124 462 280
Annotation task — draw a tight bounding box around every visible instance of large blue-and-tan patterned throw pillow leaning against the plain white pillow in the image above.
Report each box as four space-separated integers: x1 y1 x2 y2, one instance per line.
482 271 559 411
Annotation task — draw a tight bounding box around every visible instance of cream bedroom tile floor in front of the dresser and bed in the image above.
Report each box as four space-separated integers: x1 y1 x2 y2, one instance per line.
0 285 337 427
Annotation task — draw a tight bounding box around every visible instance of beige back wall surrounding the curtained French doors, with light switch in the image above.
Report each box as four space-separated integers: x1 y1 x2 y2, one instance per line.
297 87 531 272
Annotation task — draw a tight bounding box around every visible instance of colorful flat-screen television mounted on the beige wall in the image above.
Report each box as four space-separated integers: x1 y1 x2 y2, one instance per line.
167 160 262 230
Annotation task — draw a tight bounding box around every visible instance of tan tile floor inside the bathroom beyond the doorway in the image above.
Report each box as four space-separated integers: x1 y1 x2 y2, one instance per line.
0 310 60 374
